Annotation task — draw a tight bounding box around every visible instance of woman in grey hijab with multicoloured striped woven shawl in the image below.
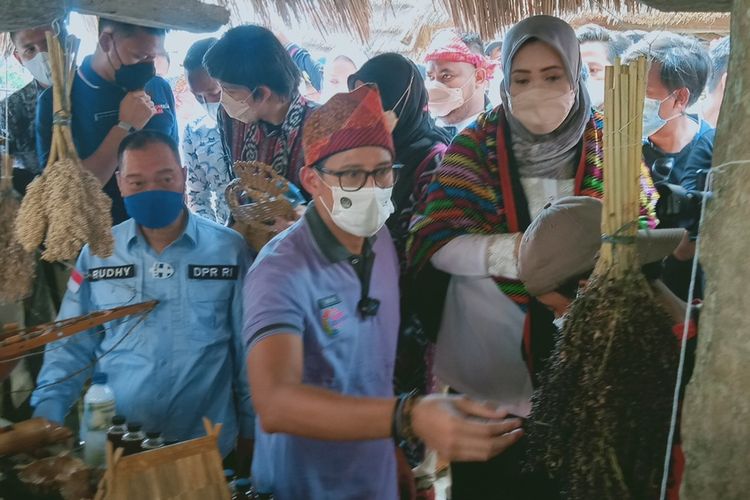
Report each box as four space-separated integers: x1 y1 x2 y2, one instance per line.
407 16 656 500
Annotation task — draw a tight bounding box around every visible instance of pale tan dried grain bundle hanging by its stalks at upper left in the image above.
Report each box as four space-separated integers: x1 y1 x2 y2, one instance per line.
16 32 114 262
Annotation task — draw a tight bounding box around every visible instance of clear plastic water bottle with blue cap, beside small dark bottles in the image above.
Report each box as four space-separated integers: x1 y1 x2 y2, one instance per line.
81 372 115 467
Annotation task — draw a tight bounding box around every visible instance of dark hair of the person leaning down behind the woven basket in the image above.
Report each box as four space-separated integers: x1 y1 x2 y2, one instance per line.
203 24 301 99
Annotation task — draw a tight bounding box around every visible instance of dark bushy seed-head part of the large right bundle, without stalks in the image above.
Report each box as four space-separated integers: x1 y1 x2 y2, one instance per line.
528 273 679 500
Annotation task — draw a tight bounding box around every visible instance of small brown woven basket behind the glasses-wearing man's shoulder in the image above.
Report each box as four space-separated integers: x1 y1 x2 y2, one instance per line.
225 162 297 251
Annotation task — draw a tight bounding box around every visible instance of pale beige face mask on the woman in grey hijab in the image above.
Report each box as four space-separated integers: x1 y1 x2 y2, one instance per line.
508 88 576 135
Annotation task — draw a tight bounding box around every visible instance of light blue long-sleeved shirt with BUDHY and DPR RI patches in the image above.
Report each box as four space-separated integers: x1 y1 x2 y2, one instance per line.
31 213 255 455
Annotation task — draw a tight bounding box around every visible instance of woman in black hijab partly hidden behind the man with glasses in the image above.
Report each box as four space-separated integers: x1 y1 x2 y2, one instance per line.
349 53 450 498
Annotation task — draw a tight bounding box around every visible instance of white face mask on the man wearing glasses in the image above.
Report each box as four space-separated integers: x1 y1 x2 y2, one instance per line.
320 184 394 238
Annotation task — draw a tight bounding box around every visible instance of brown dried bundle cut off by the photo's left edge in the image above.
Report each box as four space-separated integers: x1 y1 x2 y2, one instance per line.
0 150 36 304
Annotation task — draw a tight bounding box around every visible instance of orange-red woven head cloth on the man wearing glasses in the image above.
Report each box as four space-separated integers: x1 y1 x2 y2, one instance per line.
302 85 396 166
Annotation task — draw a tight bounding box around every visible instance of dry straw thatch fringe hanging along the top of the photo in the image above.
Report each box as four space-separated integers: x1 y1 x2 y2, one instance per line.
218 0 731 43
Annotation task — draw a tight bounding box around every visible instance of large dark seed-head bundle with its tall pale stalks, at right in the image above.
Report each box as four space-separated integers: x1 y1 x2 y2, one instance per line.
528 59 678 500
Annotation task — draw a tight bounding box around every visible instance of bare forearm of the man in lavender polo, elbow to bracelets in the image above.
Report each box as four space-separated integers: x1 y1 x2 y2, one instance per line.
256 384 395 441
